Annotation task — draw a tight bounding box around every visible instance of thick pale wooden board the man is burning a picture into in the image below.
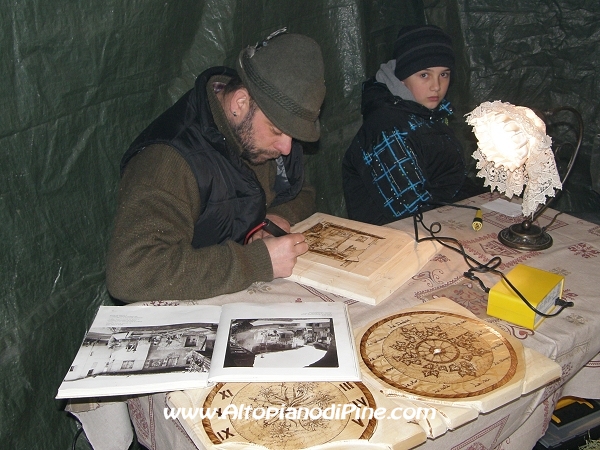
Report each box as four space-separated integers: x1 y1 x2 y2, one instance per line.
289 213 436 305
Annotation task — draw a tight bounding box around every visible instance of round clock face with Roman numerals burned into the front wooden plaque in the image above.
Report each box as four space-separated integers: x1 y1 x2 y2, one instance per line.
202 382 377 450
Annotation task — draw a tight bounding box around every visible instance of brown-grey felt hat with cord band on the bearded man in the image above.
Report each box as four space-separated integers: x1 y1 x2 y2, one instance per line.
236 30 325 142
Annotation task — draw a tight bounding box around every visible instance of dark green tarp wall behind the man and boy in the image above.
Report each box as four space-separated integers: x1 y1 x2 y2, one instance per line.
0 0 600 449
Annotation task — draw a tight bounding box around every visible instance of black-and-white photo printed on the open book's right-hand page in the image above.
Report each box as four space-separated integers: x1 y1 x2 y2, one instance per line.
224 318 339 368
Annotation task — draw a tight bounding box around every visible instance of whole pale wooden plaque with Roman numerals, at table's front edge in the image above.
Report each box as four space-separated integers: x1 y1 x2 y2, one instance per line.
167 382 426 450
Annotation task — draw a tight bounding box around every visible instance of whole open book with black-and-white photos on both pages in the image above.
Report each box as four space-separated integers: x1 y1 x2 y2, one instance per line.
56 302 360 398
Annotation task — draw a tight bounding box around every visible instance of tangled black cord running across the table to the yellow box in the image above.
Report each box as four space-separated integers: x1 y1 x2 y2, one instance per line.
413 207 574 317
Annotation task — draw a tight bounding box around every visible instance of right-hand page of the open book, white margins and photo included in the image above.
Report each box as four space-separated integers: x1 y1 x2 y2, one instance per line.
210 302 360 382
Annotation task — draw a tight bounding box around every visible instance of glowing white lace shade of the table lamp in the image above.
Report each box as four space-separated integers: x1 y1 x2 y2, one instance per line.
466 101 562 216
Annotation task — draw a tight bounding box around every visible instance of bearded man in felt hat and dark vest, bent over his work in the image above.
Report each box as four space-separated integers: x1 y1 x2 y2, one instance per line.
106 30 325 302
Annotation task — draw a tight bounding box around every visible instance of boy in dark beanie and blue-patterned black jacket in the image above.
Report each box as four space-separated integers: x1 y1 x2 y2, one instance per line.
342 25 466 225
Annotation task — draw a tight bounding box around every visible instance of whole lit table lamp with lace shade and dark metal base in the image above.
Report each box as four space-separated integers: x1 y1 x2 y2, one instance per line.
466 101 583 250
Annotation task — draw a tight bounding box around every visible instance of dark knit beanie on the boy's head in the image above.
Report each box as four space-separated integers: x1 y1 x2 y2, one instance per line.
394 25 455 81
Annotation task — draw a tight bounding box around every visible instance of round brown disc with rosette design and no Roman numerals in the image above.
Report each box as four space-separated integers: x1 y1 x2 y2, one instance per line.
360 311 517 398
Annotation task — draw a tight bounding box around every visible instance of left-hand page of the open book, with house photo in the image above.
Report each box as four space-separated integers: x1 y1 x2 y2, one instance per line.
56 305 221 398
